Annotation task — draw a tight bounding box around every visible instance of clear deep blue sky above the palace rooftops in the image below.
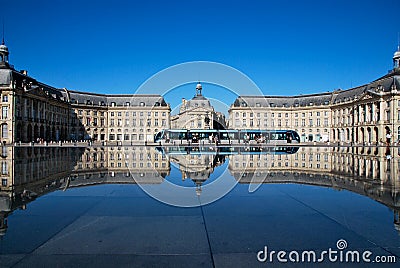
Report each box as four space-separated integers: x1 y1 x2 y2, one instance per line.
0 0 400 110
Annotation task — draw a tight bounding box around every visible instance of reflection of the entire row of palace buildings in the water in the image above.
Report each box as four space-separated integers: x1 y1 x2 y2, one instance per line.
0 143 400 234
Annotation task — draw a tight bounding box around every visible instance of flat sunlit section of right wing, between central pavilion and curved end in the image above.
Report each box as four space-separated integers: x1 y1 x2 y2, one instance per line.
228 94 331 142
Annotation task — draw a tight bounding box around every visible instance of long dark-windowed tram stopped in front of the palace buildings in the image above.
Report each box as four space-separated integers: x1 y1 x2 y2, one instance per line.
154 129 300 144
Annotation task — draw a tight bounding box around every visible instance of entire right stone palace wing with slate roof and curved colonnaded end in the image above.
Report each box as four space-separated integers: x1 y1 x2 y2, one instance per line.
228 49 400 144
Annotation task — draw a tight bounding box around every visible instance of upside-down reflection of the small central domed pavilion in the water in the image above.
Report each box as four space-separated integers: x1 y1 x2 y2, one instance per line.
170 153 225 195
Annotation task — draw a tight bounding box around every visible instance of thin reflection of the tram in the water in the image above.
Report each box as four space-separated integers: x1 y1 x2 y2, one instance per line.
156 146 299 155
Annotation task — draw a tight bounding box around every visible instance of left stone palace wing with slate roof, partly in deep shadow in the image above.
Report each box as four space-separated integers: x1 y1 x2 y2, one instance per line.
0 42 170 144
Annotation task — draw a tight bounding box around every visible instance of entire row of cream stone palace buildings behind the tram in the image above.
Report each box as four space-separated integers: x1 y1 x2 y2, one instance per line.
0 38 400 144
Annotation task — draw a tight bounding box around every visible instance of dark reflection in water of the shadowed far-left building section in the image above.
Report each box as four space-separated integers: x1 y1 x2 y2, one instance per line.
0 146 82 235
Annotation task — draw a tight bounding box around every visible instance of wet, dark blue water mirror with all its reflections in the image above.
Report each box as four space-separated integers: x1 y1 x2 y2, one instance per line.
0 146 400 267
